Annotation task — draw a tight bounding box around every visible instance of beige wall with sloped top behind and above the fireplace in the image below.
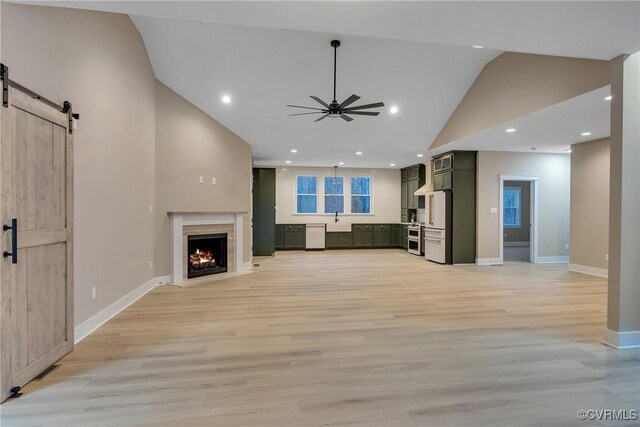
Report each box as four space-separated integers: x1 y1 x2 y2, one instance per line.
155 82 252 275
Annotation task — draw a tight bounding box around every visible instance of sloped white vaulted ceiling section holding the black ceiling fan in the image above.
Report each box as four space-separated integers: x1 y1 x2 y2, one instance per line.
133 17 499 167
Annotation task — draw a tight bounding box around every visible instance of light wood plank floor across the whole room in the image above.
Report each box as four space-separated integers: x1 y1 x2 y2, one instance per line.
0 250 640 427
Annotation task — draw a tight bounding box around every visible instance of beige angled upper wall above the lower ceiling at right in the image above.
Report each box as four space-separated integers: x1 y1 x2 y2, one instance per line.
431 52 610 148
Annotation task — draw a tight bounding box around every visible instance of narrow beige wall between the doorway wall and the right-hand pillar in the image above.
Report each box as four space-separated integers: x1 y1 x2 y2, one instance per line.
570 138 610 270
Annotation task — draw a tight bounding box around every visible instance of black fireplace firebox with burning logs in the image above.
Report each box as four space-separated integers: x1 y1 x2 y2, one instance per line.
187 233 227 279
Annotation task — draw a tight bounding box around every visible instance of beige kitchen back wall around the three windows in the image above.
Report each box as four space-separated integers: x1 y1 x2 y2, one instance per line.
276 167 400 224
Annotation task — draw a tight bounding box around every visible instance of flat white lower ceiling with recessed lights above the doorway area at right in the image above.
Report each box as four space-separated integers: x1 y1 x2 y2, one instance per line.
428 86 611 156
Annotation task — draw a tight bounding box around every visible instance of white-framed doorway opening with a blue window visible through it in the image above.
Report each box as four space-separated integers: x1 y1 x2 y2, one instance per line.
500 175 538 263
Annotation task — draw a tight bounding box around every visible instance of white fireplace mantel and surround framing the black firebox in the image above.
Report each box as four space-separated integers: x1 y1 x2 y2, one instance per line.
167 212 246 283
